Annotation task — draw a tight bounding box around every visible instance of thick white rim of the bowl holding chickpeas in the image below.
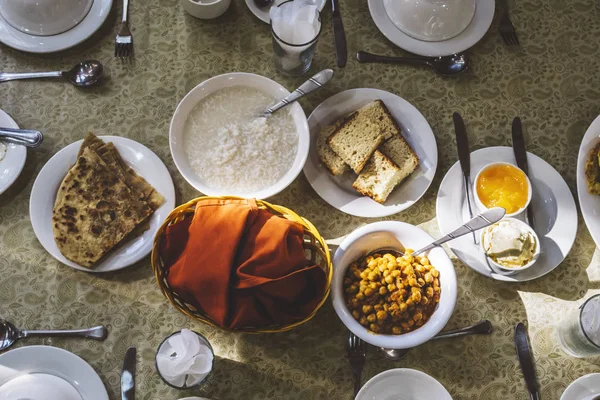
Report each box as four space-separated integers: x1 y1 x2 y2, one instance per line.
331 221 458 349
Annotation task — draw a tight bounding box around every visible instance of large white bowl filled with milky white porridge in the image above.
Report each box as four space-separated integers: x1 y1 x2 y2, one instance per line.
169 72 310 199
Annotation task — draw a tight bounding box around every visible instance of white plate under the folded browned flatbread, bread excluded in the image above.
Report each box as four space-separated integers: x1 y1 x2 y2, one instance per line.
29 136 175 272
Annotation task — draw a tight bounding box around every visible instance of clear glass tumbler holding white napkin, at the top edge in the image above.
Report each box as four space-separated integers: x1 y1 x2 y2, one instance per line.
271 0 322 76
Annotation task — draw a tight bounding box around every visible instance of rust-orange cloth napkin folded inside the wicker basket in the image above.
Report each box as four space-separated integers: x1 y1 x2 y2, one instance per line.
160 200 326 329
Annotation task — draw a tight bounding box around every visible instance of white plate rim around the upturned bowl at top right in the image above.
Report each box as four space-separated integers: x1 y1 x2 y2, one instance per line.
369 0 495 57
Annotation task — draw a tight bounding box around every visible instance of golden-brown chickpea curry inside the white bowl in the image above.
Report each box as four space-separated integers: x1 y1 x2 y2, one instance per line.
344 249 441 335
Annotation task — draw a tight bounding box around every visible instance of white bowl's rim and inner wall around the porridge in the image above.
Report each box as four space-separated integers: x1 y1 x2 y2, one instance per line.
169 72 310 199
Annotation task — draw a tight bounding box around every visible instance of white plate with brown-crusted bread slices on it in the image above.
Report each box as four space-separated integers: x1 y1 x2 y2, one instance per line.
304 89 438 218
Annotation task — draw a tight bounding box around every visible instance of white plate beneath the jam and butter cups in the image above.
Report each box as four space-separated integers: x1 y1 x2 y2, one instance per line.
436 146 577 282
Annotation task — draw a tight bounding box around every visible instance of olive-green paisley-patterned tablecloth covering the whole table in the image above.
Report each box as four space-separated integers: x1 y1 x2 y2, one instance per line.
0 0 600 400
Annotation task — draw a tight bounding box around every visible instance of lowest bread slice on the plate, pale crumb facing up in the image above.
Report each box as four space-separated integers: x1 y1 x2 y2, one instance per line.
352 150 403 204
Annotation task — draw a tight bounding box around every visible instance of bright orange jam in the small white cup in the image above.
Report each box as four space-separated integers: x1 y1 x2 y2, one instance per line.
476 164 529 214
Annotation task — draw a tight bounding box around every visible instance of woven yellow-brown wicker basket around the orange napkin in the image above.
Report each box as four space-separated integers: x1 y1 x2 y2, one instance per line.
152 196 333 333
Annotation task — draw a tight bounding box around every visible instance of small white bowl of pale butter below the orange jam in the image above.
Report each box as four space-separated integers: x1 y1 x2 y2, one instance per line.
481 218 540 273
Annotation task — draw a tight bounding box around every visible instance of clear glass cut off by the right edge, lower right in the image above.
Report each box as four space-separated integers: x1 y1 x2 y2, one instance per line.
558 294 600 358
